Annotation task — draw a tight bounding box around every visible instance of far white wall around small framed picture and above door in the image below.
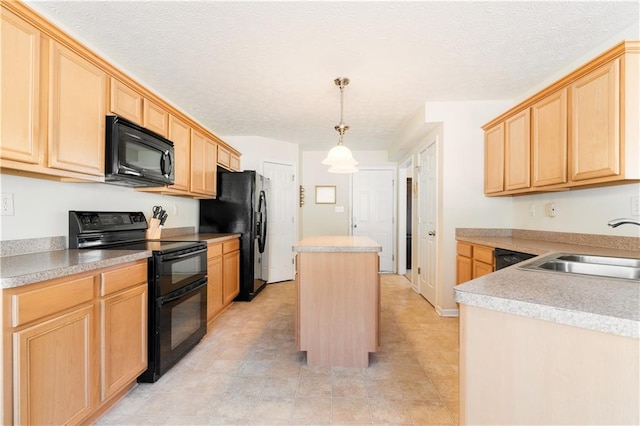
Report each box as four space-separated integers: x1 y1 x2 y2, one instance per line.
300 151 396 239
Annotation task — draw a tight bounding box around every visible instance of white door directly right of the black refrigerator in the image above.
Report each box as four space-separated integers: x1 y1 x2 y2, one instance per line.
263 162 296 283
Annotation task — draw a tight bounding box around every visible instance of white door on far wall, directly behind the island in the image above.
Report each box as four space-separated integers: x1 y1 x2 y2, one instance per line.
351 170 395 272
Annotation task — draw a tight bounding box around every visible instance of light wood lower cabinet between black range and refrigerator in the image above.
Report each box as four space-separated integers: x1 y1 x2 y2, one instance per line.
207 238 240 322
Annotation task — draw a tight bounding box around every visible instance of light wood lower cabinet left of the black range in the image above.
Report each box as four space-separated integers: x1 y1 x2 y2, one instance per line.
2 259 148 425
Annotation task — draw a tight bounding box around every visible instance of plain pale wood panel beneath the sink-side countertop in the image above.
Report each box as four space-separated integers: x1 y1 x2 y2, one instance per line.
460 304 640 425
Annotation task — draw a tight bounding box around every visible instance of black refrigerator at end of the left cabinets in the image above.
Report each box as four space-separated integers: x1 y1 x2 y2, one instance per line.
199 169 269 301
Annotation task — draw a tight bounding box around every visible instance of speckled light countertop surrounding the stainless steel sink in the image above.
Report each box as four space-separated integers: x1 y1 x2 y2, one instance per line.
454 230 640 339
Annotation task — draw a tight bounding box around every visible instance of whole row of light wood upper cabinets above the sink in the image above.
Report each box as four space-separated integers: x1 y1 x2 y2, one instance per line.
482 41 640 196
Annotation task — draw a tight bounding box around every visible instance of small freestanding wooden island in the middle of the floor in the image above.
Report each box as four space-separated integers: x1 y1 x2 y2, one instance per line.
293 236 382 368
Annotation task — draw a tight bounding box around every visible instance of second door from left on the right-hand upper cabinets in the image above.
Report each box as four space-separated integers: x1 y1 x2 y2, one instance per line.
504 108 531 191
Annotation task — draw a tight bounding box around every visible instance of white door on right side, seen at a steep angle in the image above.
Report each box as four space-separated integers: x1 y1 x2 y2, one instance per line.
418 142 438 306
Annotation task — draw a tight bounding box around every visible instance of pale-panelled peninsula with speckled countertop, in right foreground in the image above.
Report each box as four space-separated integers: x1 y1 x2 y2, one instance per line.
455 253 640 424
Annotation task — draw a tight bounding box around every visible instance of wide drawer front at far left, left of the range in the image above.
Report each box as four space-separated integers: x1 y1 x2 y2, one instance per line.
11 275 94 327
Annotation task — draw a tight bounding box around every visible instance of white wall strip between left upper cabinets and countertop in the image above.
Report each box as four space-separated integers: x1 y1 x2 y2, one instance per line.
0 171 199 241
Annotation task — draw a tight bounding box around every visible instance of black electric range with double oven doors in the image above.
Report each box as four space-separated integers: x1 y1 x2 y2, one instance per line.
69 211 207 382
